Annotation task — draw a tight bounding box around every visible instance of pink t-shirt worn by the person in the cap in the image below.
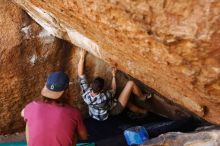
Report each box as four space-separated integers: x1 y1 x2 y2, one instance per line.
24 101 85 146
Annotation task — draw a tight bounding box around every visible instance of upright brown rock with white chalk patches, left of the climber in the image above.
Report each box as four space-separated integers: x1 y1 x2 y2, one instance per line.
0 0 69 134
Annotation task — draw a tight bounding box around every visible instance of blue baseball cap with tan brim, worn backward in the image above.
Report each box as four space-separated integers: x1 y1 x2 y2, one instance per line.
41 71 69 99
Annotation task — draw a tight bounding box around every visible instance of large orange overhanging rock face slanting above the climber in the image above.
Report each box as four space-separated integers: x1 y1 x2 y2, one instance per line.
14 0 220 124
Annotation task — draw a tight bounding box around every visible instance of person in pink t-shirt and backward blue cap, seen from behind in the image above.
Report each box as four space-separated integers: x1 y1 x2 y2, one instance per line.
21 72 87 146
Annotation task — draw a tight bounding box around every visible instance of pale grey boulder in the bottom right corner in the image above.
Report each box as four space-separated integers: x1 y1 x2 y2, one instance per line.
141 127 220 146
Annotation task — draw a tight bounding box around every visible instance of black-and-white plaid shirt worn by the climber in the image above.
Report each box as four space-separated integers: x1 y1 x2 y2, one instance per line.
79 75 117 121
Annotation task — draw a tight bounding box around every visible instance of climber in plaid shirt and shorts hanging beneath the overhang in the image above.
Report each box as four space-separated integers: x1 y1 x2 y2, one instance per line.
78 49 151 121
